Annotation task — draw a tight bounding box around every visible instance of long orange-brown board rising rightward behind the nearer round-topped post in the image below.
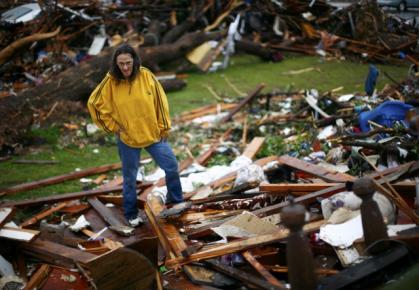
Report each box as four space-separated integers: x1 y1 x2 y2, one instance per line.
165 220 325 267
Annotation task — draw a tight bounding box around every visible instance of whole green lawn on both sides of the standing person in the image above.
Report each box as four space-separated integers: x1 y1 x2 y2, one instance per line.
0 55 408 199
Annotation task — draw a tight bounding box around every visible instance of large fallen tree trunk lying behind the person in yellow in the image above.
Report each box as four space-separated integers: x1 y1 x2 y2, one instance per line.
0 32 223 148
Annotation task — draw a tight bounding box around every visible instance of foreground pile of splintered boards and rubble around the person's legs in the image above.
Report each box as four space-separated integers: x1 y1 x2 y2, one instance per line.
0 69 419 289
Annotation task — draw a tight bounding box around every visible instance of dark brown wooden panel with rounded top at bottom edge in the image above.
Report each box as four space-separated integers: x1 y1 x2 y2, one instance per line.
86 248 156 290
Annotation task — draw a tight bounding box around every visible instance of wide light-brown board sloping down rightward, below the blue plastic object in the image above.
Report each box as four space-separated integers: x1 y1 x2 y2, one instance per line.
278 155 354 182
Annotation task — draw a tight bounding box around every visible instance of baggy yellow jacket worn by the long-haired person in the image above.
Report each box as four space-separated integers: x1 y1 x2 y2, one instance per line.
87 67 171 148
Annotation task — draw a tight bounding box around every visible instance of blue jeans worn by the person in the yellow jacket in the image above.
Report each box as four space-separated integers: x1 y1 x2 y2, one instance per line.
118 140 183 220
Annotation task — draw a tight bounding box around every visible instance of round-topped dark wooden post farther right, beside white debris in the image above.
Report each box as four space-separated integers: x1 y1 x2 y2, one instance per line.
353 177 388 246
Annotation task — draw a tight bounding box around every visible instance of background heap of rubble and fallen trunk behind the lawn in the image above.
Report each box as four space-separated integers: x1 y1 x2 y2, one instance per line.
0 0 419 155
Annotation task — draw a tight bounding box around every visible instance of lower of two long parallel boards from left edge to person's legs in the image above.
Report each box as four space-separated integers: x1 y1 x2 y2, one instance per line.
0 183 152 207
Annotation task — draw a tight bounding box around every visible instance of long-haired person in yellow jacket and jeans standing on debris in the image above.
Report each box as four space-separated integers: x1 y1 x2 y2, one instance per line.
87 44 183 227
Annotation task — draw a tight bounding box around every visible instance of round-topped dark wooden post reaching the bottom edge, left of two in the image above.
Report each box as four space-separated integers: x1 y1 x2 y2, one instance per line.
281 200 316 290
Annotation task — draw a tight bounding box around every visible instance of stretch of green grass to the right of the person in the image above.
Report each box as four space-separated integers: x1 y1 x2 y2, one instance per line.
168 55 408 115
